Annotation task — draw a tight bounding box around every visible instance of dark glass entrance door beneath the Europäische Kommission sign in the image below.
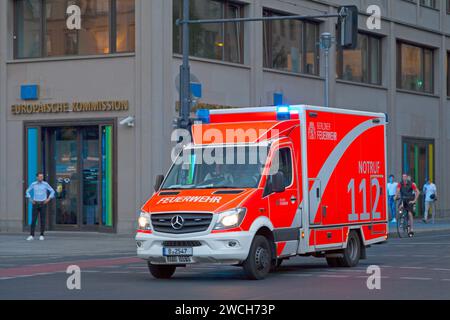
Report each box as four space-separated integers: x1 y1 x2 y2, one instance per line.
43 125 114 231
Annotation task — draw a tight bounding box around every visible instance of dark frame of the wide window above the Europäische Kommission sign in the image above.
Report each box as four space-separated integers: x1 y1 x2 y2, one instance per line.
13 0 136 60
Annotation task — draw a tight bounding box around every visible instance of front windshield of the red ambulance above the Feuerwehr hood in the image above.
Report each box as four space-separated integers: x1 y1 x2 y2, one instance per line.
162 146 269 190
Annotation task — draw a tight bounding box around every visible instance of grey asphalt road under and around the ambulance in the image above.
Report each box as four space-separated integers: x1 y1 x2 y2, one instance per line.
0 232 450 301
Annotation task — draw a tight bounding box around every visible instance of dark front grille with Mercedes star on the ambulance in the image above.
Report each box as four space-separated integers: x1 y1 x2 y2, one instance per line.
151 213 213 234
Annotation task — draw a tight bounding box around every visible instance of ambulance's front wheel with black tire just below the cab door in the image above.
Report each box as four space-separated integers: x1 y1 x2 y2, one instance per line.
242 236 273 280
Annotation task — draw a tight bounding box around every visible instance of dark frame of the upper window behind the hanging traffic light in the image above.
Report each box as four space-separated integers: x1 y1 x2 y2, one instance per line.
336 31 383 86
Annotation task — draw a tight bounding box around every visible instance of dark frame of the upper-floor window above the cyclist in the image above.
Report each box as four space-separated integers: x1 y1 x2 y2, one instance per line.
396 39 436 95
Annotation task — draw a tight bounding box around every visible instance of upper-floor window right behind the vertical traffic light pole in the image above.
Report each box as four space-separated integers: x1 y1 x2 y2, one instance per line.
173 0 244 63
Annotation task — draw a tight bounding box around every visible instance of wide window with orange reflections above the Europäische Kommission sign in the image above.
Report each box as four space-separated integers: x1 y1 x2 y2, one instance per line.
15 0 135 59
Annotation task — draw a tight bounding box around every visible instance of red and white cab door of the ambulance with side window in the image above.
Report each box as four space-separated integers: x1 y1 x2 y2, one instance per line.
266 144 301 256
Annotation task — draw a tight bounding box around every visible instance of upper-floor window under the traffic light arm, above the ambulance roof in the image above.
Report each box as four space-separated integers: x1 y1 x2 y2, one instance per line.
264 10 320 75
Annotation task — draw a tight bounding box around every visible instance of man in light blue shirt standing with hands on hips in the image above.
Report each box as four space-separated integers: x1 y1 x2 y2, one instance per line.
26 172 55 241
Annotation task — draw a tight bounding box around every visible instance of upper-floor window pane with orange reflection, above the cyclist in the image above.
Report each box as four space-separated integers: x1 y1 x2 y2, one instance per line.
397 42 434 93
